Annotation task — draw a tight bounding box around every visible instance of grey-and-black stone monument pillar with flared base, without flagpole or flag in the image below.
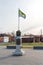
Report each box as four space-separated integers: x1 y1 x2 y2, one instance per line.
13 30 24 56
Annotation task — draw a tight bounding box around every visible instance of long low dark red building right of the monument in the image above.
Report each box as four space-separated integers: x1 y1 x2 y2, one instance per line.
22 34 40 43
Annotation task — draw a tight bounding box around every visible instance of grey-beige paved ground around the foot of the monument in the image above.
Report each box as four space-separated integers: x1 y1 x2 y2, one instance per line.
0 47 43 65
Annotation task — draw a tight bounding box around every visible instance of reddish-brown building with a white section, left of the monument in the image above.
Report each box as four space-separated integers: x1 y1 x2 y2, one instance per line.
0 33 15 42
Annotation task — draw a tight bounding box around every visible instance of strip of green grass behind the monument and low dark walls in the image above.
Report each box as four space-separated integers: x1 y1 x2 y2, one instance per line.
0 42 43 47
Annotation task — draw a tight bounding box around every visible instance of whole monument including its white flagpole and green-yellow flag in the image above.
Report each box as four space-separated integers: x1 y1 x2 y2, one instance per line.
13 9 26 56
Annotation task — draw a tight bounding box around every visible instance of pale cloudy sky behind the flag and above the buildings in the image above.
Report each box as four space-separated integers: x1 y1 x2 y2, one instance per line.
0 0 43 34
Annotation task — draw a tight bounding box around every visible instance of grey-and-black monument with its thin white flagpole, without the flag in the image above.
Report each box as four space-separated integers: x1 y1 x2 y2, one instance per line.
13 10 24 56
